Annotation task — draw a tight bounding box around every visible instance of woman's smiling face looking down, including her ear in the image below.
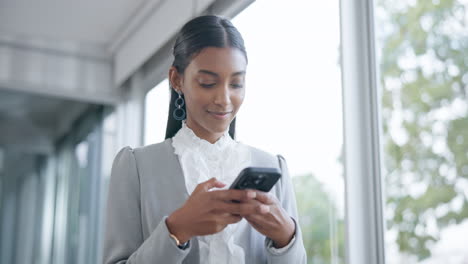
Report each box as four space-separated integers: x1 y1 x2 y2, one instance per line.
170 47 247 143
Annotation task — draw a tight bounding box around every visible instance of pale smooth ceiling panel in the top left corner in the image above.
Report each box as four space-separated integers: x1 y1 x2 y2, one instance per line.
0 0 149 46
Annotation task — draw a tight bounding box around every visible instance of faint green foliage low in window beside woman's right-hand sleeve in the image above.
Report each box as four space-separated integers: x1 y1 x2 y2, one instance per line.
292 174 344 264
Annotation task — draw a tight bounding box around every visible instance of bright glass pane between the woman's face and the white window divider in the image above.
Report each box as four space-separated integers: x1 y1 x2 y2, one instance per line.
233 0 344 263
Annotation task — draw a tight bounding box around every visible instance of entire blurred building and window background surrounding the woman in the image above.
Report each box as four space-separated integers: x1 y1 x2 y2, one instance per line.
0 0 468 264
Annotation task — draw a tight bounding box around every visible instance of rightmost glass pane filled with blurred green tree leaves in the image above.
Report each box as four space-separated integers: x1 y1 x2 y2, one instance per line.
376 0 468 264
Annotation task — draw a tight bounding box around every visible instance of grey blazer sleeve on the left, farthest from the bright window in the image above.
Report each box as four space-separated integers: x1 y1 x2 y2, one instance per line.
103 147 190 264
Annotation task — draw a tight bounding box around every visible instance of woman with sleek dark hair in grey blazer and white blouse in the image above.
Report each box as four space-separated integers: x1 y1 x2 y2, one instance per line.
104 16 306 264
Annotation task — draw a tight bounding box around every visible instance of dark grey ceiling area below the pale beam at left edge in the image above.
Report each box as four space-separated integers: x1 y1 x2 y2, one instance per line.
0 90 92 154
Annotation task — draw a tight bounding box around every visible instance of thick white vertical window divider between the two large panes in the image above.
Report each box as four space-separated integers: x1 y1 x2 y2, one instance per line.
340 0 385 264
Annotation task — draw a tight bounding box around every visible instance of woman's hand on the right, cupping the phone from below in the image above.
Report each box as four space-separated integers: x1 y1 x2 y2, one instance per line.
240 190 296 248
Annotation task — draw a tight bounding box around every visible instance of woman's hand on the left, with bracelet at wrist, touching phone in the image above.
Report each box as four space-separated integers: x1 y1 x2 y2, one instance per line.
166 178 255 243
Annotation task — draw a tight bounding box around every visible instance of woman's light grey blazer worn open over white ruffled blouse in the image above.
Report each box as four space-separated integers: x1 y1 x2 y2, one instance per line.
103 139 307 264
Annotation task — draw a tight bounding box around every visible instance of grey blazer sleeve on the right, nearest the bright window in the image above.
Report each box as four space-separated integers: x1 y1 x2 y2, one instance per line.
265 155 307 264
